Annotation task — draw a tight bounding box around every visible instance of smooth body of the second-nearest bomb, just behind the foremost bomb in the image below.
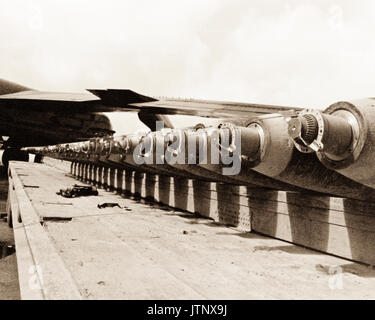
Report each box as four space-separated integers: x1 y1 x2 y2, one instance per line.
247 110 375 200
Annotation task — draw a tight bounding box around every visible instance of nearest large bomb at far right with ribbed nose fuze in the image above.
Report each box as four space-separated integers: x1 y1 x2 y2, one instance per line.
288 99 375 188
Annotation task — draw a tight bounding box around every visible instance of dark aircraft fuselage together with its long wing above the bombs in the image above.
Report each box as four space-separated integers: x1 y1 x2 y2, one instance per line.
0 79 300 147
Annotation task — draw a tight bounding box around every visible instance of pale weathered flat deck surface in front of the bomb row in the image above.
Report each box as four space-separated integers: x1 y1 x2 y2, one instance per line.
8 164 375 299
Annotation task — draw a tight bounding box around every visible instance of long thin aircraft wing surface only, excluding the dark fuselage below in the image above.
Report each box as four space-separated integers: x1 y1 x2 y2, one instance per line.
0 82 302 118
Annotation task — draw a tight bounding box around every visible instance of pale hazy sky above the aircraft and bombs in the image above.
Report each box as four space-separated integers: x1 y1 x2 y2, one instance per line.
0 0 375 108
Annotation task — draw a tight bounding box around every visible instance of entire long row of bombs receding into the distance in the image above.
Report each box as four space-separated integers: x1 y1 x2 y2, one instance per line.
26 99 375 201
